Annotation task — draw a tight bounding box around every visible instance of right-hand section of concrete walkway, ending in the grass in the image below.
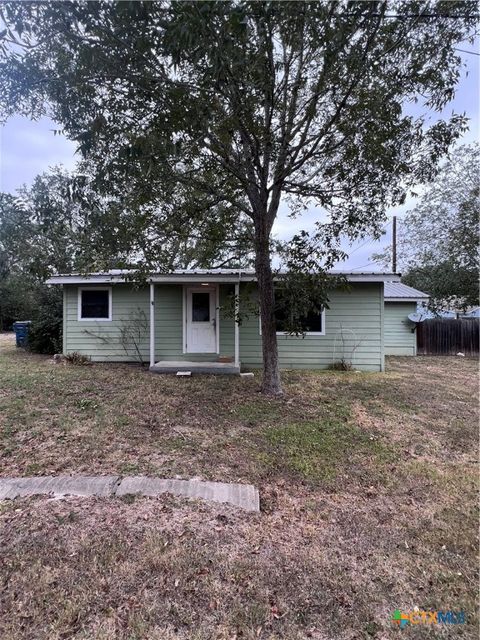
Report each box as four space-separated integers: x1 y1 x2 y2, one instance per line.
116 476 260 511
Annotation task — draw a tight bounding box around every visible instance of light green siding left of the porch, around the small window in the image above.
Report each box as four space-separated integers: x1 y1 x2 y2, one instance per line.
63 284 149 362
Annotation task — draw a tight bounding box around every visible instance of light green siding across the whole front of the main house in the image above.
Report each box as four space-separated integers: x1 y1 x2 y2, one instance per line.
64 283 384 371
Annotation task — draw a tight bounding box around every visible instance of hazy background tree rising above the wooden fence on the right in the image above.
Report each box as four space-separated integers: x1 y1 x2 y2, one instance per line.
375 143 480 311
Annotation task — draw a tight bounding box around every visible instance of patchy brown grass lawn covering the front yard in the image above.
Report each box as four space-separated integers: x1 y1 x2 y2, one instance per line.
0 336 478 640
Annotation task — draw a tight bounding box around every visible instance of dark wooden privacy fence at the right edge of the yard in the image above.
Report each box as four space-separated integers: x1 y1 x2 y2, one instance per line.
416 318 480 356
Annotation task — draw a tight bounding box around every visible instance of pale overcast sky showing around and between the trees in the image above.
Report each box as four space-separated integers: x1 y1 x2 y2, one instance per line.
0 44 480 271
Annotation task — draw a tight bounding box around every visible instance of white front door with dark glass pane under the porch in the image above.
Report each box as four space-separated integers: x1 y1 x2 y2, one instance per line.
185 287 217 353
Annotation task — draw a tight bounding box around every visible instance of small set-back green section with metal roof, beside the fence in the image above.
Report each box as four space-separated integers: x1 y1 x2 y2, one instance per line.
384 282 429 356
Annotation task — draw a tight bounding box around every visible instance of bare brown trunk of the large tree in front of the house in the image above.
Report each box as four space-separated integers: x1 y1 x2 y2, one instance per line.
255 225 282 395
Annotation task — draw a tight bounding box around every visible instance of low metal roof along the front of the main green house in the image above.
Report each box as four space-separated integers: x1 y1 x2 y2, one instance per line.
46 269 400 284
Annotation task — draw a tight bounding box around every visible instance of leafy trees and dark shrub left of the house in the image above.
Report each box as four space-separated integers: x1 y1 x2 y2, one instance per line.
0 168 76 338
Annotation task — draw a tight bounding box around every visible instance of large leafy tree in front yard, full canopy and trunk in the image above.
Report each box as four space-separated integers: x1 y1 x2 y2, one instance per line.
0 0 477 393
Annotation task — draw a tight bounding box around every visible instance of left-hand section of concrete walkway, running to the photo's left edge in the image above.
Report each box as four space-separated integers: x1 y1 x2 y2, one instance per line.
0 476 120 500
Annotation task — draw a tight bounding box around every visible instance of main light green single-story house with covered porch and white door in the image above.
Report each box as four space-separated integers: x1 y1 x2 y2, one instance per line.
47 269 400 373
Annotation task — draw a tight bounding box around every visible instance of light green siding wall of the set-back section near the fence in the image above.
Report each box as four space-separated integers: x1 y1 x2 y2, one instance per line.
385 302 417 356
